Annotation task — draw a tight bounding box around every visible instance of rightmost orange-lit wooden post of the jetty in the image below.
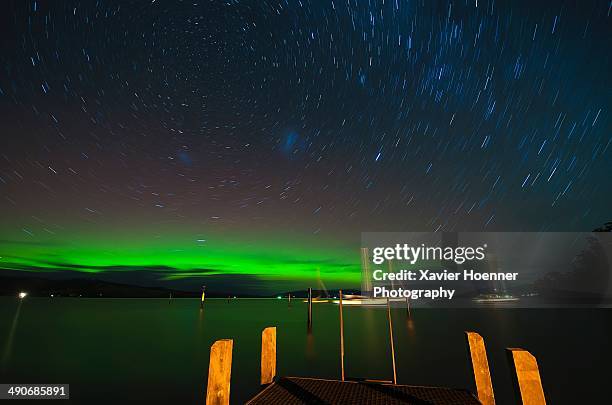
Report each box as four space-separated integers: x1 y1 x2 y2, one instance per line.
506 348 546 405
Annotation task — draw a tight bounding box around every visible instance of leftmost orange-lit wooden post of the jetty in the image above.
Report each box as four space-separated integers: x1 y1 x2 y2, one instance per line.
206 339 234 405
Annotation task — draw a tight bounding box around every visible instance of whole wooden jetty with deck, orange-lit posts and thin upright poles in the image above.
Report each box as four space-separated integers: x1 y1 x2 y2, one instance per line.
206 290 546 405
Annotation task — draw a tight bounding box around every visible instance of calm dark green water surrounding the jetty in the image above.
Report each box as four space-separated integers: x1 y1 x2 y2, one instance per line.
0 298 612 404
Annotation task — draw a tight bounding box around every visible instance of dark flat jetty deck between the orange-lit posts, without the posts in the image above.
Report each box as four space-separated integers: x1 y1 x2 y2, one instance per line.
247 377 480 405
